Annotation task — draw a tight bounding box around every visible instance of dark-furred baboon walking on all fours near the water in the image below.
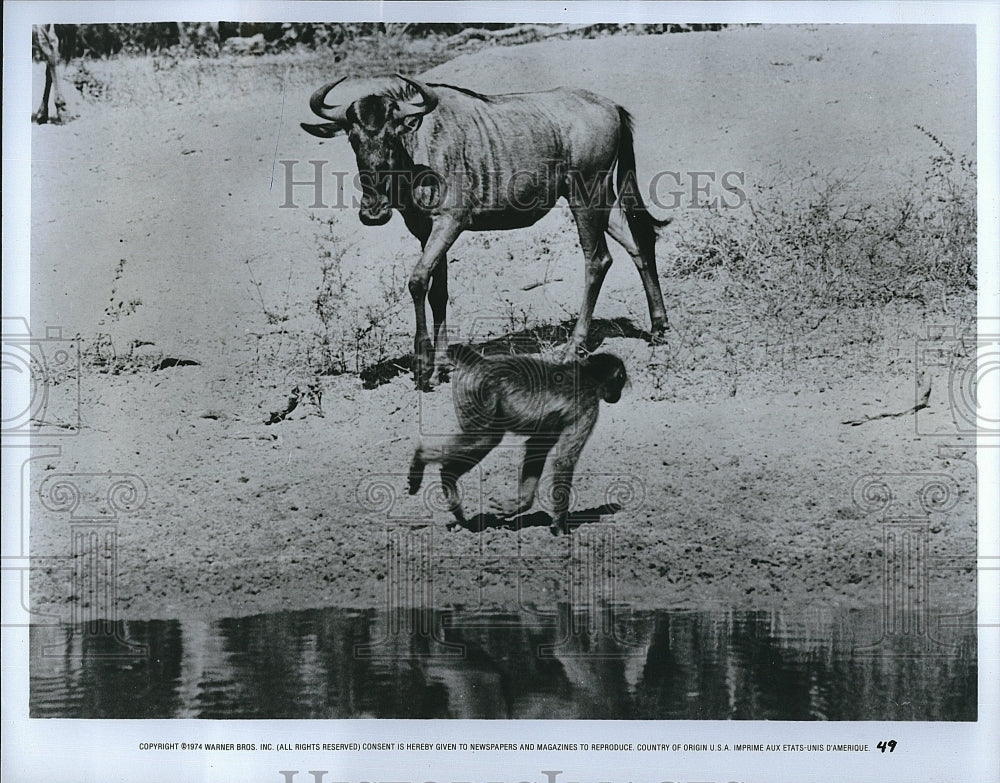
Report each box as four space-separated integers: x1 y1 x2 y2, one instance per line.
409 345 628 535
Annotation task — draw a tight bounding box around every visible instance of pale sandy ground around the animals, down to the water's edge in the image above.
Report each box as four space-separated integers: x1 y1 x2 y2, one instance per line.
30 27 976 618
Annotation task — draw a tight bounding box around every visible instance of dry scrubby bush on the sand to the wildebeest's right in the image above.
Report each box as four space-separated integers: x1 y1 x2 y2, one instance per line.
672 128 976 318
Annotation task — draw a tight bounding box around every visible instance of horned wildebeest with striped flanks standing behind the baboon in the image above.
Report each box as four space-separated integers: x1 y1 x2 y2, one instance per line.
302 74 667 389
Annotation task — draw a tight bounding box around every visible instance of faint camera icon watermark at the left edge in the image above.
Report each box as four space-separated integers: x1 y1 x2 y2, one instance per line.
2 318 80 438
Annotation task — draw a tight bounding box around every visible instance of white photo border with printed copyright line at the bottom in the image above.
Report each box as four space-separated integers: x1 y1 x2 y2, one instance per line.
3 2 1000 783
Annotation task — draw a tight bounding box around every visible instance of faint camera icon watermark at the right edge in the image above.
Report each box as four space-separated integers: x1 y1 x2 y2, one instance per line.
915 319 1000 437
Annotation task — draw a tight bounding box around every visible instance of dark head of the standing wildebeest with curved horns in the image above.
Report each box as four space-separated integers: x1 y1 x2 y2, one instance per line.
302 74 438 226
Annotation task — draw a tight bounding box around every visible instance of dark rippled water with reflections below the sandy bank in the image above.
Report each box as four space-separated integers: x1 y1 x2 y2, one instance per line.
31 607 977 720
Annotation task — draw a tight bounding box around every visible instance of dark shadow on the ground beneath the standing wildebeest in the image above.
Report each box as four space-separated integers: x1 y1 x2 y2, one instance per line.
361 316 652 389
